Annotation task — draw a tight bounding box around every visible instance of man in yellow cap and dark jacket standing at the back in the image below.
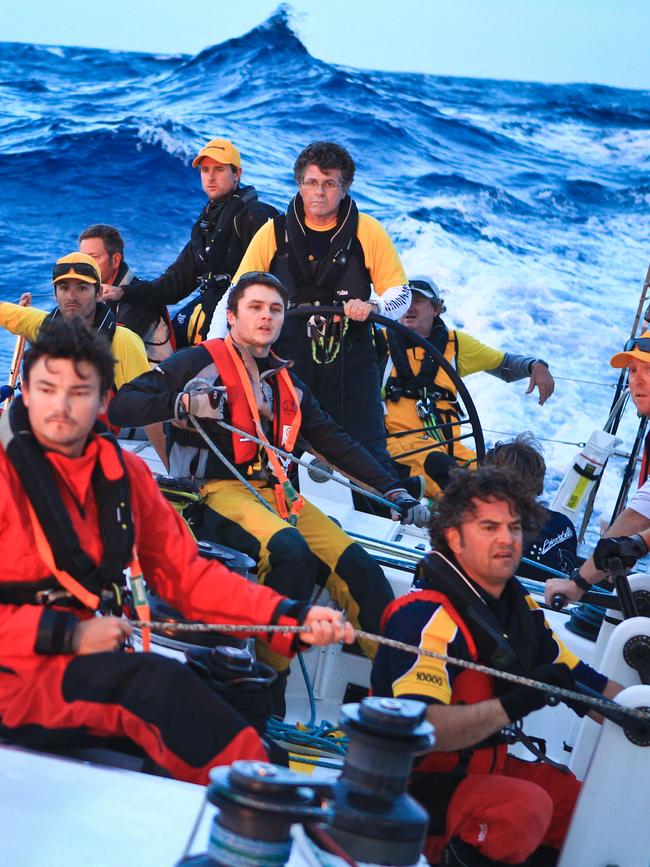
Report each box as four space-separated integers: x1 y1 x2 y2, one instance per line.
104 138 278 347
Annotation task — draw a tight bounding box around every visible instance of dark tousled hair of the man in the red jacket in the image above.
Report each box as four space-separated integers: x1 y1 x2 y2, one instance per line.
23 316 115 396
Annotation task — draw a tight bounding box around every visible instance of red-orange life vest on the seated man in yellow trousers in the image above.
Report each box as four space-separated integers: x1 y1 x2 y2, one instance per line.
203 335 304 527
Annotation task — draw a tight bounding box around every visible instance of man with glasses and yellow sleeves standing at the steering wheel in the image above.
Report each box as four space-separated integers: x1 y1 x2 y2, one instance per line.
209 141 410 472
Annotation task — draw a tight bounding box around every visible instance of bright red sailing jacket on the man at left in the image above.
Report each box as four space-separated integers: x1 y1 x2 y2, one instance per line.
0 439 295 715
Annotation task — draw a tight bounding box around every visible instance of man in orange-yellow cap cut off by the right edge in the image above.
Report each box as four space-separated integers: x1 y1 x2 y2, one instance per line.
545 331 650 602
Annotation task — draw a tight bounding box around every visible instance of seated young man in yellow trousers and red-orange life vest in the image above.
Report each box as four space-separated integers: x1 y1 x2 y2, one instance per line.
110 272 428 716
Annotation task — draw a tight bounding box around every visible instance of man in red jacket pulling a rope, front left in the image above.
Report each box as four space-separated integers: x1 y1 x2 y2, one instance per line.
0 318 353 783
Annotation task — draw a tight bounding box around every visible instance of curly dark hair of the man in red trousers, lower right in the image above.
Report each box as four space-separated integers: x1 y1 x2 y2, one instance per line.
429 466 545 551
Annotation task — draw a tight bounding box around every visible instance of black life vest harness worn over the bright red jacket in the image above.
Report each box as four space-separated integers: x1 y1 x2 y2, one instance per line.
0 397 149 644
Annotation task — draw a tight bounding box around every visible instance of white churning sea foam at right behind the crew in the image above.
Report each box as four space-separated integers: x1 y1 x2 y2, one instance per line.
391 209 648 514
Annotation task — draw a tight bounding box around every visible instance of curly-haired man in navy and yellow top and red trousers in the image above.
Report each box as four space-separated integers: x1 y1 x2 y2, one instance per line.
372 467 620 867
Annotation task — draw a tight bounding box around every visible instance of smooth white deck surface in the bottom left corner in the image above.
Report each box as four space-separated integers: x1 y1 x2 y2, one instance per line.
0 747 213 867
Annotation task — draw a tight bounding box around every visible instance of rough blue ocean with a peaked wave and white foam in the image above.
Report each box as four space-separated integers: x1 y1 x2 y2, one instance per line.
0 9 650 508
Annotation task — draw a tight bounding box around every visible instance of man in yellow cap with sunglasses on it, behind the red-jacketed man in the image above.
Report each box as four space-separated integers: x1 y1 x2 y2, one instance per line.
0 252 166 460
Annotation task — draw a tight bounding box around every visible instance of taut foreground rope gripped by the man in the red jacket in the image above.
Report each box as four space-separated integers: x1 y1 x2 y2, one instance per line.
129 620 650 723
